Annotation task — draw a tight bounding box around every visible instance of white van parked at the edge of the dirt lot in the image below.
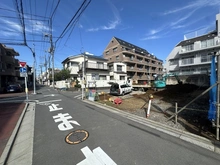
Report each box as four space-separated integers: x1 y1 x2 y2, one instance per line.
110 83 132 95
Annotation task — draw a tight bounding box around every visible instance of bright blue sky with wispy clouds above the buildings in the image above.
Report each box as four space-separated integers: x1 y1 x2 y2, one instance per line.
0 0 220 75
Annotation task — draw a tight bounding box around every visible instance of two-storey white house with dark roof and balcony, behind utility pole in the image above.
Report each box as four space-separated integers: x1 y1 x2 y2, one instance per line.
62 53 122 88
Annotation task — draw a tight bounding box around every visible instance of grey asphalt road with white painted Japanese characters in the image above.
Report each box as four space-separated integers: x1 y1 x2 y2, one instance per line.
33 88 220 165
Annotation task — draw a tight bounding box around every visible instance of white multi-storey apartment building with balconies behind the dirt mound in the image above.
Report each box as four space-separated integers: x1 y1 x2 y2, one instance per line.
164 14 220 86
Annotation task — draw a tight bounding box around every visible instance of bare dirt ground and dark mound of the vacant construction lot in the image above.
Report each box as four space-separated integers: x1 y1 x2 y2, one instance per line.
96 84 216 139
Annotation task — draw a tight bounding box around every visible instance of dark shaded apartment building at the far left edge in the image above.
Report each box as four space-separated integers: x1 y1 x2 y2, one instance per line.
0 44 20 93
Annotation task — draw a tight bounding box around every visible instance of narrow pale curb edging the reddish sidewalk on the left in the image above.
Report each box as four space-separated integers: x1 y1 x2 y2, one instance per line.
0 103 29 165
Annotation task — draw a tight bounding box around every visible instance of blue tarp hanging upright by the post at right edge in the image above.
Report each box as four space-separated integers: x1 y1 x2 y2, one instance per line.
208 56 217 121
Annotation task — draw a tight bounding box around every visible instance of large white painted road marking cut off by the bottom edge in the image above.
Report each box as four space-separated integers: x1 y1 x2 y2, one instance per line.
77 146 117 165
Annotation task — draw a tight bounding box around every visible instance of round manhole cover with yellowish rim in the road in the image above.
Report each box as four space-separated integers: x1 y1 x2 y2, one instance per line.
65 130 89 144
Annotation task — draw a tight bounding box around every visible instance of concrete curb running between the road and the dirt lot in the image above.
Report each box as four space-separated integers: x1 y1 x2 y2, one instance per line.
83 100 220 154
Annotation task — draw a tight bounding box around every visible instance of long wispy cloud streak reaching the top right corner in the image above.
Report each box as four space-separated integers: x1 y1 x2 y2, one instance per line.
163 0 220 15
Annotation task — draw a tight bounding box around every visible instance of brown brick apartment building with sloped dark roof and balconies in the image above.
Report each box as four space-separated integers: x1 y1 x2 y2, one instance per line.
103 37 163 84
